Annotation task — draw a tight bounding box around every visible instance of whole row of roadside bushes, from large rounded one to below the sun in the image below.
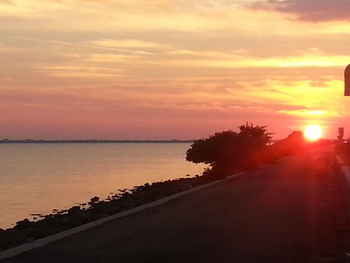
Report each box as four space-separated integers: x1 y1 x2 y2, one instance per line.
186 124 330 179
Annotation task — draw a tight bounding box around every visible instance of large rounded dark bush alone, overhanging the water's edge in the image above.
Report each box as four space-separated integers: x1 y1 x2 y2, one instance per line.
186 124 271 178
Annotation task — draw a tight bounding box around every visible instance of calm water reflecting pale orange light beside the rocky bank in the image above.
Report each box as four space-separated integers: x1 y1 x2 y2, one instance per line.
0 143 204 228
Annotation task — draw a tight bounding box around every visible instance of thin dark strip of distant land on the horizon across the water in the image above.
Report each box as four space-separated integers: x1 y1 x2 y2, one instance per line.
0 139 194 144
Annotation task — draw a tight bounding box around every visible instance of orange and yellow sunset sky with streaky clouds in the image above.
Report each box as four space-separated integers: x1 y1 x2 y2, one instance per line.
0 0 350 139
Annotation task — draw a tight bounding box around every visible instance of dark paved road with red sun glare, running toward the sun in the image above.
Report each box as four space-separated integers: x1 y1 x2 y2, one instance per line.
4 150 350 263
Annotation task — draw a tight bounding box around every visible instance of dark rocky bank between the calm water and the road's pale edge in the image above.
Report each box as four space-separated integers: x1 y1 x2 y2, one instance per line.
0 171 230 253
